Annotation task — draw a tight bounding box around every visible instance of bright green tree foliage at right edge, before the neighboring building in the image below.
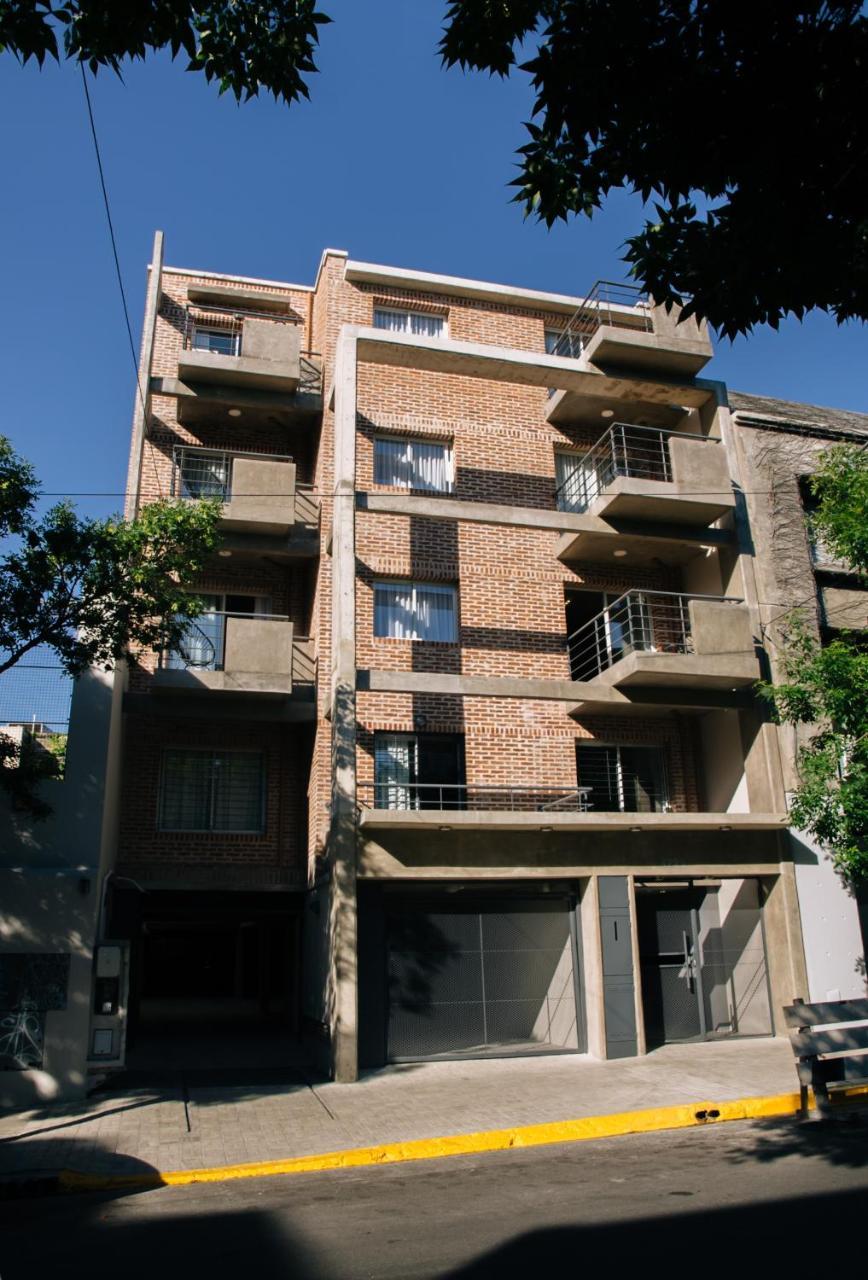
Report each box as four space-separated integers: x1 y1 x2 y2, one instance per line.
760 445 868 881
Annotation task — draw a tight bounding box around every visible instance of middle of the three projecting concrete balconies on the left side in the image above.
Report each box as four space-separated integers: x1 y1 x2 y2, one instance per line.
172 445 319 536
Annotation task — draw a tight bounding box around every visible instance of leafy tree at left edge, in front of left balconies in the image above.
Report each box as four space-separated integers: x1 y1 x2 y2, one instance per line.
0 436 220 817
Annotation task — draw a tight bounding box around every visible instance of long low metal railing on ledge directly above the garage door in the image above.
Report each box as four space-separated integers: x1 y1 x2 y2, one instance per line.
357 782 590 813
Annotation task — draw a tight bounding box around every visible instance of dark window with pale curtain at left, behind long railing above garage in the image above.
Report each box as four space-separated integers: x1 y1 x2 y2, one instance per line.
374 733 465 809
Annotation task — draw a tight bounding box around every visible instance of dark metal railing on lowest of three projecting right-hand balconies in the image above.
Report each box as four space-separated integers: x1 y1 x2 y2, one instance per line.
567 589 741 681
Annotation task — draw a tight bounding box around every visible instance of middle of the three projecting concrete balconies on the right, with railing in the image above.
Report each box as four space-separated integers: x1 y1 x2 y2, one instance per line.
557 422 735 525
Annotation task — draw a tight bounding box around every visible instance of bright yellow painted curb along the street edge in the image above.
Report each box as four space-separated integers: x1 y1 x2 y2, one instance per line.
59 1091 824 1192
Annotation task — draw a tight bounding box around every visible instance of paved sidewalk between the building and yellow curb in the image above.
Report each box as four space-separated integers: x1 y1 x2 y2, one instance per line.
0 1039 796 1178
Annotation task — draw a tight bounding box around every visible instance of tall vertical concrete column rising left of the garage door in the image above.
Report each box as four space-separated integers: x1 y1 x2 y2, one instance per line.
329 330 358 1080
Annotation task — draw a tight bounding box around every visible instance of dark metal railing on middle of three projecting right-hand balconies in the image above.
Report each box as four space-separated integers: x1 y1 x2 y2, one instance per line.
556 422 718 513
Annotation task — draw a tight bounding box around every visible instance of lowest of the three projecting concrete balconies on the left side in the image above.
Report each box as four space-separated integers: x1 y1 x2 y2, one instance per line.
154 613 316 698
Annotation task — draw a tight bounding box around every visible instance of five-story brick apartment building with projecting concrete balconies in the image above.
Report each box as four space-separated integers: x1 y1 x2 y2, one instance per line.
3 237 865 1105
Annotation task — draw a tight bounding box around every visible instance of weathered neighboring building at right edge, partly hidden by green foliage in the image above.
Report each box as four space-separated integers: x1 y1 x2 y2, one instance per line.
728 392 868 1001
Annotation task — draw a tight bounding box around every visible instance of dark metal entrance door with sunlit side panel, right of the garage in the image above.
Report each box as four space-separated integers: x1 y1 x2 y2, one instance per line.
636 879 772 1048
